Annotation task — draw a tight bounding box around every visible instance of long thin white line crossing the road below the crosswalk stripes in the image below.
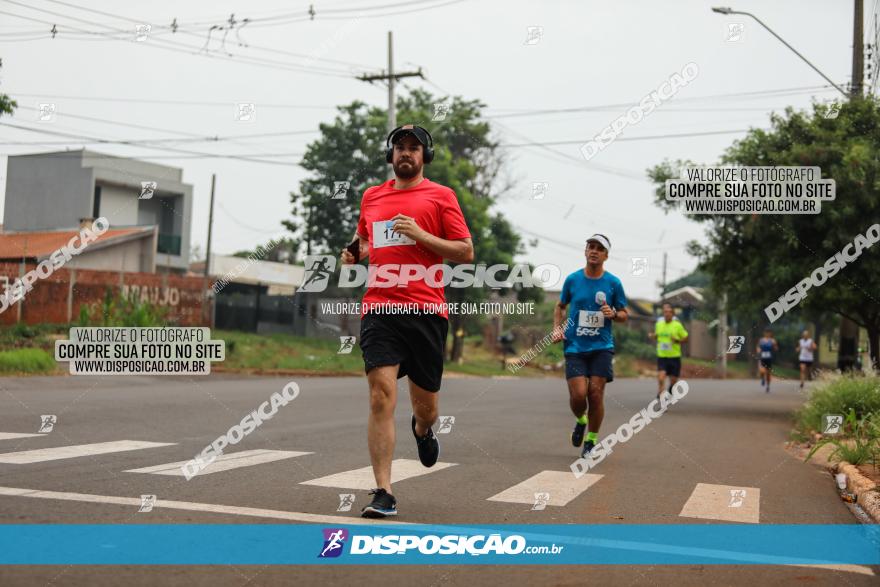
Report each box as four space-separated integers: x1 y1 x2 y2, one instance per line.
0 487 412 526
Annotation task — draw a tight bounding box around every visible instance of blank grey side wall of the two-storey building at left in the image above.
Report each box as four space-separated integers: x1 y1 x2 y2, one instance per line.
3 151 94 231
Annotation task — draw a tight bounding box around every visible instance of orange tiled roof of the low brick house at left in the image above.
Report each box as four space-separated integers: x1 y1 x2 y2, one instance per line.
0 226 154 261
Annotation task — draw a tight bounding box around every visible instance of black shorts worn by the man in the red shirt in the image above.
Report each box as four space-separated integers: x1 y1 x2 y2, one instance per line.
361 313 449 391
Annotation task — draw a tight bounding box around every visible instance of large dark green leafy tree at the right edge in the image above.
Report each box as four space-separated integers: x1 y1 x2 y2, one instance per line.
648 98 880 365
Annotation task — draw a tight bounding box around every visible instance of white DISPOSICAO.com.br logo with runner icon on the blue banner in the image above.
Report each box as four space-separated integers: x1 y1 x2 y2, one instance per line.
319 528 565 558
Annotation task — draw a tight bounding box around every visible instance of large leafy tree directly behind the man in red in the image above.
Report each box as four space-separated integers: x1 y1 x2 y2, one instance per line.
282 90 542 360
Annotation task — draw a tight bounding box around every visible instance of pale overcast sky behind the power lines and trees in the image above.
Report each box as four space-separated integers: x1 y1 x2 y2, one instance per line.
0 0 877 298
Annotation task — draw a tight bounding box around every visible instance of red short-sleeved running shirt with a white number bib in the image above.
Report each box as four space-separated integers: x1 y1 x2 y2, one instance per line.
358 179 471 318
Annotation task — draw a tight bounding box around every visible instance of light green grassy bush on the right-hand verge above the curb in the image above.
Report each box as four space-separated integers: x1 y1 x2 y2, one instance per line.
795 374 880 433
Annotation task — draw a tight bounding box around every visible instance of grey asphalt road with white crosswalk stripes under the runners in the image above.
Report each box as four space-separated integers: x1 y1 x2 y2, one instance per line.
0 376 880 587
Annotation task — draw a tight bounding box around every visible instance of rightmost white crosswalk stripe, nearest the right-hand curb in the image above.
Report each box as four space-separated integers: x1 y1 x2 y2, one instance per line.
678 483 761 524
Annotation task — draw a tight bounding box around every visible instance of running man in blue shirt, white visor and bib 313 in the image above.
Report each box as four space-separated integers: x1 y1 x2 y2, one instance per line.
553 234 628 458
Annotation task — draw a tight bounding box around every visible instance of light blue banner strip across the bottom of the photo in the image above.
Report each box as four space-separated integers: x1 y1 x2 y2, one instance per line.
0 524 880 565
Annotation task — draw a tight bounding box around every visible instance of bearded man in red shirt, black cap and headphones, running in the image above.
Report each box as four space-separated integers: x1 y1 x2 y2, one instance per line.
341 124 474 518
